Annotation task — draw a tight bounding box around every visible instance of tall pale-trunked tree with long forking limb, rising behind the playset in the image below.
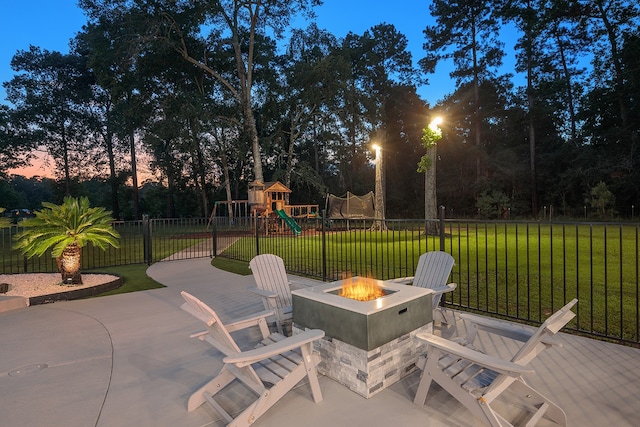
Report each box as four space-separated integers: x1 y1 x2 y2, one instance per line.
81 0 320 185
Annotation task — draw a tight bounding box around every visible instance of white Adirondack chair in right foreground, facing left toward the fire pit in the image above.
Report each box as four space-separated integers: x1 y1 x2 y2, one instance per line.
414 299 578 427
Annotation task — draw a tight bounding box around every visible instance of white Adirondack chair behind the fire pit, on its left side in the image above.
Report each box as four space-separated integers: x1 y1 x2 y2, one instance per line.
249 254 293 334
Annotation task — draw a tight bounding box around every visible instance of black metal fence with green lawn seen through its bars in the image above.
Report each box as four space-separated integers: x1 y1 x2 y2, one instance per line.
0 217 640 346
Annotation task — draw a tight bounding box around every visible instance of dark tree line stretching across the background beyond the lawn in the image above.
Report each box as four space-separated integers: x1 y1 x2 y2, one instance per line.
0 0 640 219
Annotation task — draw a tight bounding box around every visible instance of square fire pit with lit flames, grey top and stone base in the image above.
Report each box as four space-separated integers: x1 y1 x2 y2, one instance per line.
292 277 432 398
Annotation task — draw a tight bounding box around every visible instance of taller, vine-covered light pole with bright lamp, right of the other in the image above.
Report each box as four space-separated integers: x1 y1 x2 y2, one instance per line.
418 117 442 234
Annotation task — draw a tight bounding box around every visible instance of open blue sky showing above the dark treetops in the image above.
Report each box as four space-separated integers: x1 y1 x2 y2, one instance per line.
0 0 454 105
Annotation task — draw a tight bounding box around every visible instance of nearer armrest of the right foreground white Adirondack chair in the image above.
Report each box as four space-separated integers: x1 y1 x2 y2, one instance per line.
416 332 535 376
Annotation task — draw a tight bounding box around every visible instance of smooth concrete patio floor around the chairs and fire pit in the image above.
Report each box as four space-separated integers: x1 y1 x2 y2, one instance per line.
0 258 640 427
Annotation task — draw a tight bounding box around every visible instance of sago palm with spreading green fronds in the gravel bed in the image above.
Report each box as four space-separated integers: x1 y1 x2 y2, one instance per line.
14 197 120 284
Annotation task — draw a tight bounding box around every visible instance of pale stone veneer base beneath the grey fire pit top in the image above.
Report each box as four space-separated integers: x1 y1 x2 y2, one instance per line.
293 323 433 399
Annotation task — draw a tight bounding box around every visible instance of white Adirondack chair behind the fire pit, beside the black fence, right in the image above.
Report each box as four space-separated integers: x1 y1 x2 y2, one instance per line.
393 251 457 323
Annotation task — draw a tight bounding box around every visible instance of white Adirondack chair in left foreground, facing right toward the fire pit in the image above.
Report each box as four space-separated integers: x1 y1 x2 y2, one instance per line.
181 291 324 427
